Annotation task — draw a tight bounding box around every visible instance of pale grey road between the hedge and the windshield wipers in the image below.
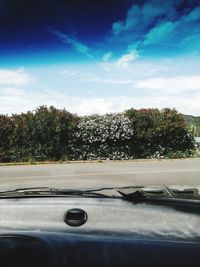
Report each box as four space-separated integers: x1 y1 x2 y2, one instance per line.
0 159 200 190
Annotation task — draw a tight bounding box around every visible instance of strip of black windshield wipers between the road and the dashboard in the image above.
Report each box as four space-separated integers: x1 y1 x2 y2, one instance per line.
0 186 200 203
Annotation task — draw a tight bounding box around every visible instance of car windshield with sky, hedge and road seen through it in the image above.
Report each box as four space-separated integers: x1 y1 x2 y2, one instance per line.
0 0 200 195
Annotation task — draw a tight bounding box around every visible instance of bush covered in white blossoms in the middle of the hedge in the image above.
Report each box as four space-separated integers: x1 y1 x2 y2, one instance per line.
72 113 133 160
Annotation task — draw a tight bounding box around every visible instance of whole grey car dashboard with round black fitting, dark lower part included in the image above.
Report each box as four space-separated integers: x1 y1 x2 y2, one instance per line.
0 197 200 267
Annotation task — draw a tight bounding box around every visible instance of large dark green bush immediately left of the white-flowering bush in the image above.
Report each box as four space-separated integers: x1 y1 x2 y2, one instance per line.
1 106 79 161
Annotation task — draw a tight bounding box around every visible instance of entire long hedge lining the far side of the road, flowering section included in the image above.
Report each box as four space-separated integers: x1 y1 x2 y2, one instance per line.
0 106 195 162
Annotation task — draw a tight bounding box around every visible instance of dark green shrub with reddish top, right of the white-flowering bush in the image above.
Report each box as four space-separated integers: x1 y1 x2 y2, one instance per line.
126 109 194 158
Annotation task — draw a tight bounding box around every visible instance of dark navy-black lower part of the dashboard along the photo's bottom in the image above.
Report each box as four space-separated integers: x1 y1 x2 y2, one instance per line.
0 232 200 267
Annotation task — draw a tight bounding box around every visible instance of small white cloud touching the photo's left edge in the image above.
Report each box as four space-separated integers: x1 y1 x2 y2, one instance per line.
0 69 33 86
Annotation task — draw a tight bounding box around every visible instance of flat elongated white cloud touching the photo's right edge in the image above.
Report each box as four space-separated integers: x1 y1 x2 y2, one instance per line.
135 75 200 93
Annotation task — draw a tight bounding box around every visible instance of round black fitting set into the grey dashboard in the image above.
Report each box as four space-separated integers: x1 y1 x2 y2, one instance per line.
64 209 88 227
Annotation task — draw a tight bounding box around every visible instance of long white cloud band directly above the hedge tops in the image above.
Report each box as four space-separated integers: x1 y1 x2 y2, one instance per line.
0 87 200 115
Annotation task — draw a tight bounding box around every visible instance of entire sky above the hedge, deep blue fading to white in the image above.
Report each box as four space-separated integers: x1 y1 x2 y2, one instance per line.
0 0 200 115
